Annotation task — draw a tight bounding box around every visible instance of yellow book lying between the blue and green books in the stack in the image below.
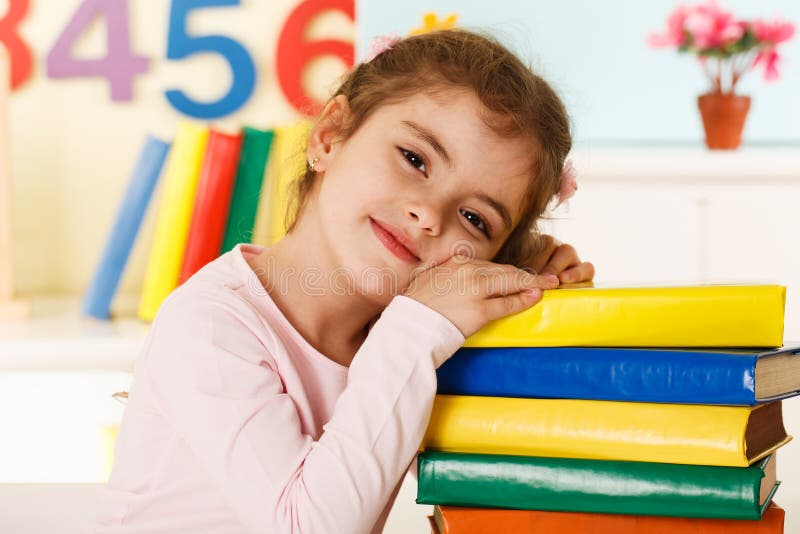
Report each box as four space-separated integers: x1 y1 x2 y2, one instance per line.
423 395 791 467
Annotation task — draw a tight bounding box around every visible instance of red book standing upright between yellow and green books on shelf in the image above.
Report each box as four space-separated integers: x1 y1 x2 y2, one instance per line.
178 129 242 284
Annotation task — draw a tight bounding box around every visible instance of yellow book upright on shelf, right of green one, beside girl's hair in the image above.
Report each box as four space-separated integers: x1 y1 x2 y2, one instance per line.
253 120 311 246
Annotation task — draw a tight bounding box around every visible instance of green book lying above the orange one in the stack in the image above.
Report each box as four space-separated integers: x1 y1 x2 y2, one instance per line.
417 452 780 519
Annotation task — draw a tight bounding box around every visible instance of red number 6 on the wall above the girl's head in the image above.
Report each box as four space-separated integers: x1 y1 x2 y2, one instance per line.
277 0 355 115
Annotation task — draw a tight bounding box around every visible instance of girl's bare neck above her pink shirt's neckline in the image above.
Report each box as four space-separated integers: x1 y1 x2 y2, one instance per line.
253 228 385 366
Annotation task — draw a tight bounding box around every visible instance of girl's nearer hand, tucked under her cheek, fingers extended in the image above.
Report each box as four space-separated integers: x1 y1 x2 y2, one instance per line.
403 256 558 337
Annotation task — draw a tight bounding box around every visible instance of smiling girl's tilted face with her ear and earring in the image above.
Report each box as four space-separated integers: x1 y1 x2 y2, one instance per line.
304 89 534 293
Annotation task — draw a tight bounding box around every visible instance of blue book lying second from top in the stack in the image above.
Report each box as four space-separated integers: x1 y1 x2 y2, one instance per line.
437 345 800 406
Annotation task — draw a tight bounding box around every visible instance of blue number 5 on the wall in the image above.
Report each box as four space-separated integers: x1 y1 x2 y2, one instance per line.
164 0 256 119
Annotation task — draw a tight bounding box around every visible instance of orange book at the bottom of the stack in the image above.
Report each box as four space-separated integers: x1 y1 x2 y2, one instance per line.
429 502 784 534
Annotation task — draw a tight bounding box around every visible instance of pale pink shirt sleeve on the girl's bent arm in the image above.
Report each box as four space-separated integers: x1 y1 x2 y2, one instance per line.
142 291 464 534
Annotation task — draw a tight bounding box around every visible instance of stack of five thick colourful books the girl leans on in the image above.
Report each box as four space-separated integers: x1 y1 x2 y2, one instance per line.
417 285 800 534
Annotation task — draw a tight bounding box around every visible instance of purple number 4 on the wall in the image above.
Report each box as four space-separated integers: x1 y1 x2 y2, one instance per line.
46 0 149 102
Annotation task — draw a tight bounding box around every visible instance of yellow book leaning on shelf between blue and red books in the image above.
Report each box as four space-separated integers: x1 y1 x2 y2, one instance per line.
139 122 208 321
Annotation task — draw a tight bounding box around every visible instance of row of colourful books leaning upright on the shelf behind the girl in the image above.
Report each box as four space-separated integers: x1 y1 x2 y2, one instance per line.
83 121 309 322
